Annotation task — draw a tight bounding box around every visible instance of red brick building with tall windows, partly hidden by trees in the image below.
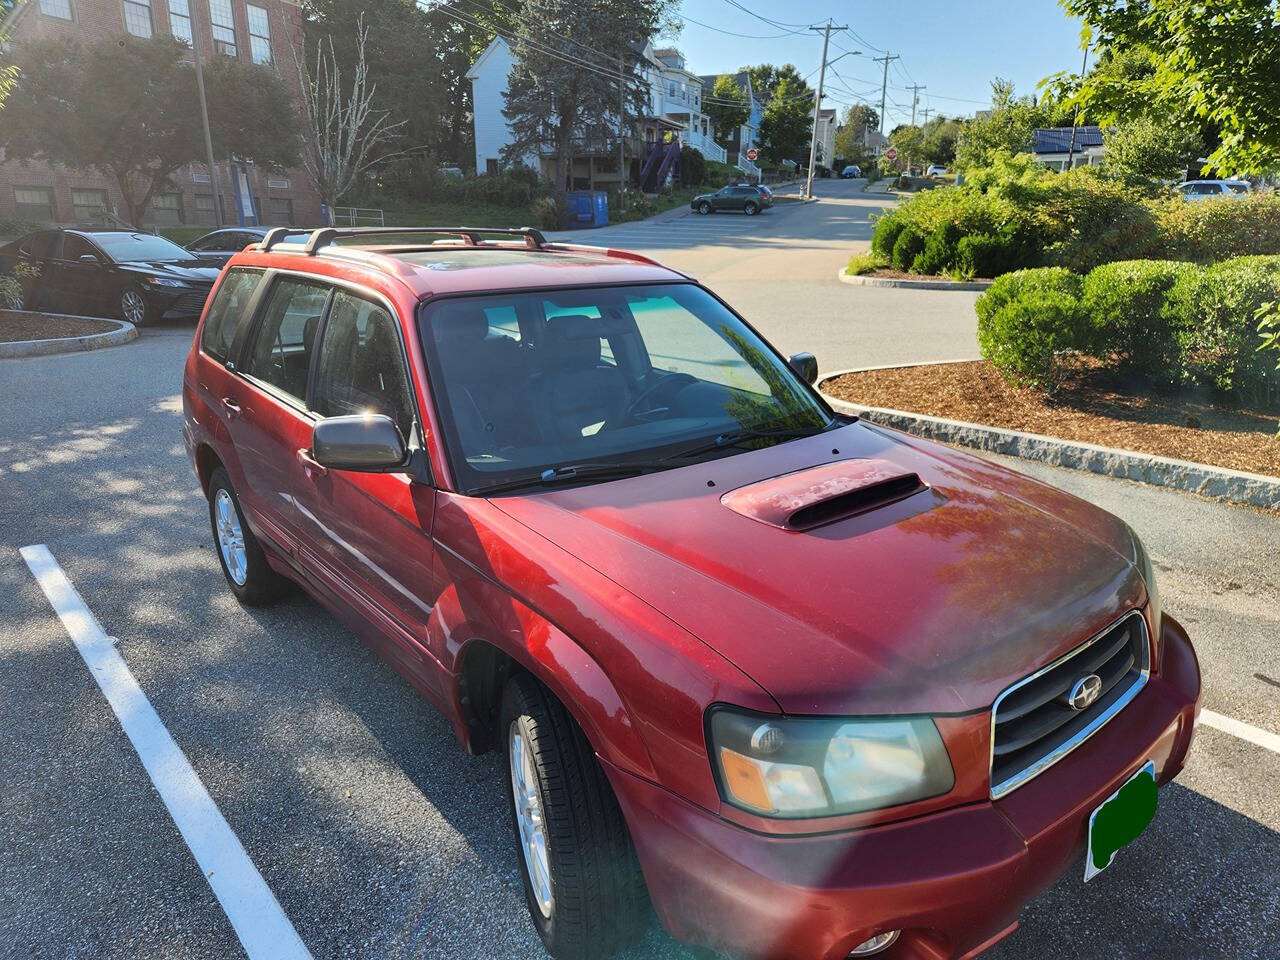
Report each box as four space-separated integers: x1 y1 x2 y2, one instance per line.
0 0 320 227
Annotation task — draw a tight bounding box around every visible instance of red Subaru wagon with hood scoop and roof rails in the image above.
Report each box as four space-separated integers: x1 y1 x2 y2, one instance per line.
183 228 1199 960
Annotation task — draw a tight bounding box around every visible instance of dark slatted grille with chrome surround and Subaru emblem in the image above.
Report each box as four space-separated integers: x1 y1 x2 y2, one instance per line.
991 611 1151 800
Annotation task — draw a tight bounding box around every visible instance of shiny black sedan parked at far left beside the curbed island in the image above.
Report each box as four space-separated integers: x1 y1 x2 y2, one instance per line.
0 230 218 325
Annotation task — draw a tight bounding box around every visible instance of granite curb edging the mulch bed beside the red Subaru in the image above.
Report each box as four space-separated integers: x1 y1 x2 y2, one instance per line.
818 361 1280 509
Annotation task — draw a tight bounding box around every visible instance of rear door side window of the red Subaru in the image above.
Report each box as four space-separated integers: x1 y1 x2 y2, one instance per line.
244 279 329 401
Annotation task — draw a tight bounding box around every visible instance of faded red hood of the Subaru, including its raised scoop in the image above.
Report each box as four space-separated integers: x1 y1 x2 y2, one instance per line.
494 422 1146 714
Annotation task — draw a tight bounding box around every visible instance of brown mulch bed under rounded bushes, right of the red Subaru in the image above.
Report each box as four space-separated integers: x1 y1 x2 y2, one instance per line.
823 358 1280 476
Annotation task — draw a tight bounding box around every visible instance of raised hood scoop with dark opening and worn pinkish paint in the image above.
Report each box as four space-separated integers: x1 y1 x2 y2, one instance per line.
721 460 929 530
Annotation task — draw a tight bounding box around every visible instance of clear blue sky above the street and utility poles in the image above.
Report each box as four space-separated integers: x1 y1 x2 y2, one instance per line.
662 0 1082 131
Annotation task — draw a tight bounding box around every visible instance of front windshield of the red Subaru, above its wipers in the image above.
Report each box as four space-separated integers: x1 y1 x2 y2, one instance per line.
422 284 831 492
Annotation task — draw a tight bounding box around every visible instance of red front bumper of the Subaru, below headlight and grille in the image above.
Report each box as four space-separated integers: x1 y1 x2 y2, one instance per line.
607 616 1201 960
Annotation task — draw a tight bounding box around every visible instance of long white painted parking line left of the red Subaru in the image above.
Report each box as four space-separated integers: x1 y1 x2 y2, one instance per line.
20 544 311 960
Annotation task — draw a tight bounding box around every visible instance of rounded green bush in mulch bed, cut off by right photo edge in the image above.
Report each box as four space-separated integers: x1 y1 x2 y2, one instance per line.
1166 256 1280 398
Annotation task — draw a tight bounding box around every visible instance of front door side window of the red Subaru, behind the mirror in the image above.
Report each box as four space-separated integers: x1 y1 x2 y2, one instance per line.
314 291 413 439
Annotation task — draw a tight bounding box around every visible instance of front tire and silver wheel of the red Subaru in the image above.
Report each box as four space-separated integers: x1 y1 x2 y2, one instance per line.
498 673 649 960
